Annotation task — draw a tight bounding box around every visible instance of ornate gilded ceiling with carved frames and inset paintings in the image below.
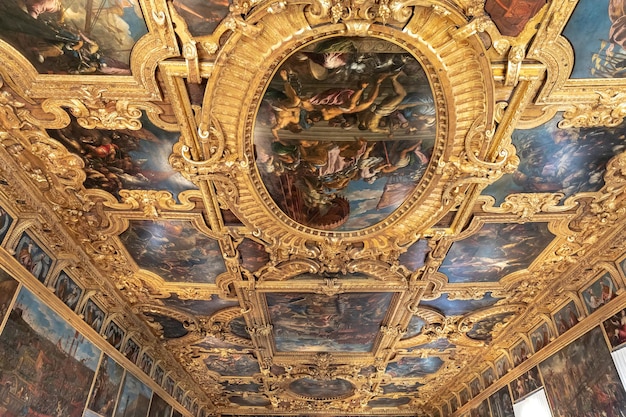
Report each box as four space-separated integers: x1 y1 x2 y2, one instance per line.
0 0 626 416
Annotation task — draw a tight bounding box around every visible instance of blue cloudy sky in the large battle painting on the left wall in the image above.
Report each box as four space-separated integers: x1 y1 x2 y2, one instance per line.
14 288 100 371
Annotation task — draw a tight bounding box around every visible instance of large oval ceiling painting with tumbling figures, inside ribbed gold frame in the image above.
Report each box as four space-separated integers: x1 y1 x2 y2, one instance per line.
254 37 437 231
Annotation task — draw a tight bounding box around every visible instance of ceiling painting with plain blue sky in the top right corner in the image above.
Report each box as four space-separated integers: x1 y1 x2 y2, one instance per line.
563 0 626 78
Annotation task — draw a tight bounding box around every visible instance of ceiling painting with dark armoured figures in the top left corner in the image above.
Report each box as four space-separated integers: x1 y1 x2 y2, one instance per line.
0 0 148 75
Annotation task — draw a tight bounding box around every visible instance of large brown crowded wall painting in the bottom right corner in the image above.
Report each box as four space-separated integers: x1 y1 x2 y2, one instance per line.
539 327 626 416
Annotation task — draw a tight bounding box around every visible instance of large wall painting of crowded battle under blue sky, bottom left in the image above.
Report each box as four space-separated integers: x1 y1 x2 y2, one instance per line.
0 288 101 417
